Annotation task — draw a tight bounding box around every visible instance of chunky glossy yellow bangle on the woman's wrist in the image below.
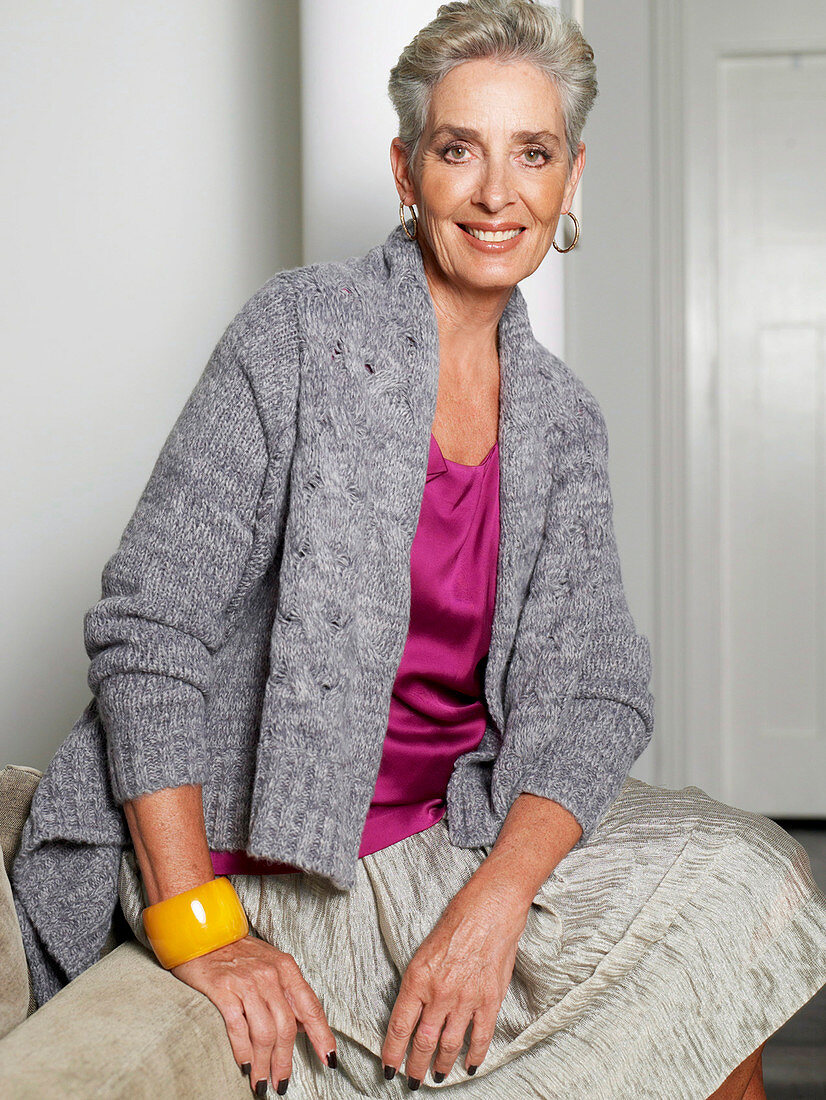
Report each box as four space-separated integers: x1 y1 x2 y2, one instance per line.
142 875 250 970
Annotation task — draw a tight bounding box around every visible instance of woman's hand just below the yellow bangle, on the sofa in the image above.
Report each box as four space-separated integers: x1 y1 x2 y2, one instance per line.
170 935 337 1097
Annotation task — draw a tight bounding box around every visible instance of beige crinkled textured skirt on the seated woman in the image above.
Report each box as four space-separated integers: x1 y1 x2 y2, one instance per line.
114 777 826 1100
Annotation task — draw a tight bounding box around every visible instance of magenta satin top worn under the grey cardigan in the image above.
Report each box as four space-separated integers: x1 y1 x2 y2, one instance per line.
210 432 499 875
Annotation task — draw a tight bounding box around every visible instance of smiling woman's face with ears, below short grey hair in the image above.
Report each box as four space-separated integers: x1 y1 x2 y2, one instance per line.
390 58 585 293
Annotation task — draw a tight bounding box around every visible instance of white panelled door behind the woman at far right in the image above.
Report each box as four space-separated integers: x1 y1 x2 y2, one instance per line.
680 0 826 816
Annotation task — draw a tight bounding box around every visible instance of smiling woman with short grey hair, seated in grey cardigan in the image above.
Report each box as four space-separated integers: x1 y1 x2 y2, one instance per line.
8 0 826 1100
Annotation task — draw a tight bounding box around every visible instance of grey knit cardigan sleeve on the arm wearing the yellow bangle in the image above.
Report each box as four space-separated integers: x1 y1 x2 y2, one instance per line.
84 315 278 804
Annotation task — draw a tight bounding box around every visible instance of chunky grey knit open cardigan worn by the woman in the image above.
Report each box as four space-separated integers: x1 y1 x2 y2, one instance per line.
6 226 653 1004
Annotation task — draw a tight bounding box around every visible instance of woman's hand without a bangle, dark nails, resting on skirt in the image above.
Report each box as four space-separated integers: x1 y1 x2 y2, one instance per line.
382 879 530 1089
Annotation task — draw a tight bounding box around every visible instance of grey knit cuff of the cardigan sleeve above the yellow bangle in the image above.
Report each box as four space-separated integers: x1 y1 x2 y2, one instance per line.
96 672 209 804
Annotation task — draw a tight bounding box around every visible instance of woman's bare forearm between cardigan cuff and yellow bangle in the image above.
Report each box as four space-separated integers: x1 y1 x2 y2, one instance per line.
123 785 216 905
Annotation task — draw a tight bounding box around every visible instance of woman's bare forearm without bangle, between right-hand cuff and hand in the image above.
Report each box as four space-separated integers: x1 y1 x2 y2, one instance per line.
462 792 582 913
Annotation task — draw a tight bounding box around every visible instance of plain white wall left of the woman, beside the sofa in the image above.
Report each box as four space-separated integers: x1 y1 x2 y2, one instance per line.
0 0 301 769
